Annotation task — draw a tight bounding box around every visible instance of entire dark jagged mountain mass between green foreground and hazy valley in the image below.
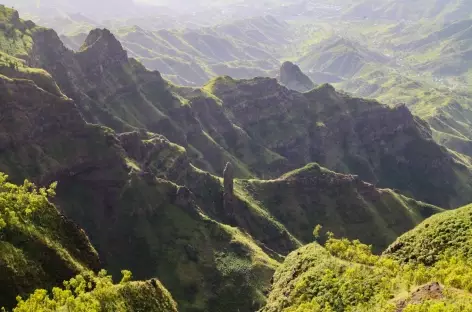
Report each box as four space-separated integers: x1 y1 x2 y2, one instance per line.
0 7 470 312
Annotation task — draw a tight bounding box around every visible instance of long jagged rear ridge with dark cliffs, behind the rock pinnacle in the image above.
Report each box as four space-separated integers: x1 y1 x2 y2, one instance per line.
24 18 472 207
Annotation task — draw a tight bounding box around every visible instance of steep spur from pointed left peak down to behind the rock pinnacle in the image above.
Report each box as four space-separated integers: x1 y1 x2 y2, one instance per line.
22 23 292 177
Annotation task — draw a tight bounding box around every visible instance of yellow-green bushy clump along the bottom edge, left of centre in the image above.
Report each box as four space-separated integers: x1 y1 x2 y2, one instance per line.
13 270 177 312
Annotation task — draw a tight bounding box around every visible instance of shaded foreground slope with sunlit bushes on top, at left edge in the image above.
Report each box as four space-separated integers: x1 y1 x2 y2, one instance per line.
0 174 100 308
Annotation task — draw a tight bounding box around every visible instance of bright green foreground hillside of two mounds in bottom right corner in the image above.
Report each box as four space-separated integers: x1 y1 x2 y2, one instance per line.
261 202 472 312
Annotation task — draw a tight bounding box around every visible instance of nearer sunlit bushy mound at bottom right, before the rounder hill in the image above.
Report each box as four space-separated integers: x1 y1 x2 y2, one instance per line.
262 236 472 312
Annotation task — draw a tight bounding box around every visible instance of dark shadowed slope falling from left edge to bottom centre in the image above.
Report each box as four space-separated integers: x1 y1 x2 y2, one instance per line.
0 59 284 311
